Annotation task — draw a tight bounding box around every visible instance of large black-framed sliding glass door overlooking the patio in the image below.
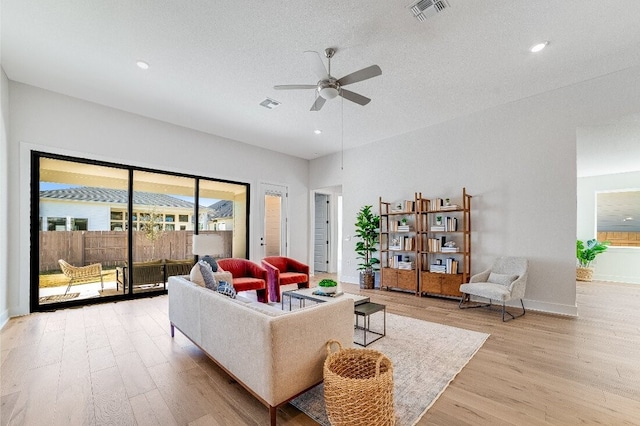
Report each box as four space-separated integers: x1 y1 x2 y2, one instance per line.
31 152 249 310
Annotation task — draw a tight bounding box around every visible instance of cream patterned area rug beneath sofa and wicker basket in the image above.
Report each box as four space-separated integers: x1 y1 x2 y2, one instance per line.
291 313 489 426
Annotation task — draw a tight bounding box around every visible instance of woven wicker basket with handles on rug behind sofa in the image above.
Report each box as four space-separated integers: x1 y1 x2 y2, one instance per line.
324 340 396 426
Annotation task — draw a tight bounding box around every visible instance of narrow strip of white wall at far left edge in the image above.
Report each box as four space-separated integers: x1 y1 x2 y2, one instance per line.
0 68 11 328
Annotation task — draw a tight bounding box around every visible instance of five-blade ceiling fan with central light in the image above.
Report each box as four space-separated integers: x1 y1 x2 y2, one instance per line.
273 47 382 111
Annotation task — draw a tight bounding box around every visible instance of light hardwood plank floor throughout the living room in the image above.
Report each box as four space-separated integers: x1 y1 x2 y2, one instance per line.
0 282 640 426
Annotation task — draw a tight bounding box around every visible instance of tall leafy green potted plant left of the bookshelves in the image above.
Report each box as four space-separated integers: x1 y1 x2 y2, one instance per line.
355 206 380 288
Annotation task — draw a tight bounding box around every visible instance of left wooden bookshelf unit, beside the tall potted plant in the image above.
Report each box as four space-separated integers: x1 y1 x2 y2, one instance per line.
379 196 419 294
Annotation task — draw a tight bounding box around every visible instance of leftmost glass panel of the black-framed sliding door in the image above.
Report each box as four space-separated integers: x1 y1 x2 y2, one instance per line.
36 157 129 306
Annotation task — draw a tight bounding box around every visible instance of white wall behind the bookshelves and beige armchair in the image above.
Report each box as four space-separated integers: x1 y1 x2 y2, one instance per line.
310 64 640 315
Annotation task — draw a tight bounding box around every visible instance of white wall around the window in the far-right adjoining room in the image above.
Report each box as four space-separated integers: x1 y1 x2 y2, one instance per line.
577 172 640 284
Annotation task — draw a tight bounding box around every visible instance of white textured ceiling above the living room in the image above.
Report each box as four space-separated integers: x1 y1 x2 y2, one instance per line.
1 0 640 159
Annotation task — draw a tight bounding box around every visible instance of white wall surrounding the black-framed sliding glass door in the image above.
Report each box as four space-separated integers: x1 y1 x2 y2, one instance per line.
3 82 309 316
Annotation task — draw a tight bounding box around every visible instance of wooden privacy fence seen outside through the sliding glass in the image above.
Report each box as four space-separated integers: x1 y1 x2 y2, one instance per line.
39 231 233 272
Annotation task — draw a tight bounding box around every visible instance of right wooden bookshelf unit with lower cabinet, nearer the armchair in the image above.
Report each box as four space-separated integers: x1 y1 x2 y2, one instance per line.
416 188 471 297
